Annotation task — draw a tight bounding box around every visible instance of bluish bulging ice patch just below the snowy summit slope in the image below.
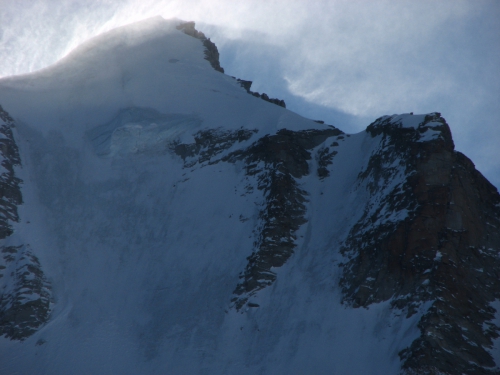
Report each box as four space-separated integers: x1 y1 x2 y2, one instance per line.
87 107 202 157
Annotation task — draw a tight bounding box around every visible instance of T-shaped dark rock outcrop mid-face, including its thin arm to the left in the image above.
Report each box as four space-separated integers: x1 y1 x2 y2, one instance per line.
171 127 343 310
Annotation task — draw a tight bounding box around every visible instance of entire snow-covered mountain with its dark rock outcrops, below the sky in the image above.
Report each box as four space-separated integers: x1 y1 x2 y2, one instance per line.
0 17 500 374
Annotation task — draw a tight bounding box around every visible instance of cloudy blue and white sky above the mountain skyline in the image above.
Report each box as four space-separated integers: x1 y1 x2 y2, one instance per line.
0 0 500 187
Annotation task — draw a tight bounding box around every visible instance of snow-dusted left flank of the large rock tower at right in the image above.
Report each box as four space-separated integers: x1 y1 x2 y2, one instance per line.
341 116 454 313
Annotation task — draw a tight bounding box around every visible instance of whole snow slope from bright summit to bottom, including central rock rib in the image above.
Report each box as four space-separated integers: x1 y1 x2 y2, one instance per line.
0 18 498 374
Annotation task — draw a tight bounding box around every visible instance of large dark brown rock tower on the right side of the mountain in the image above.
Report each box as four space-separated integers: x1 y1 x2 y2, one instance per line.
341 113 500 374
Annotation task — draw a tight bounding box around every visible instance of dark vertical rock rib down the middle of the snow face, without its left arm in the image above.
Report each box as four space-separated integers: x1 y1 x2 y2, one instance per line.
227 128 342 310
